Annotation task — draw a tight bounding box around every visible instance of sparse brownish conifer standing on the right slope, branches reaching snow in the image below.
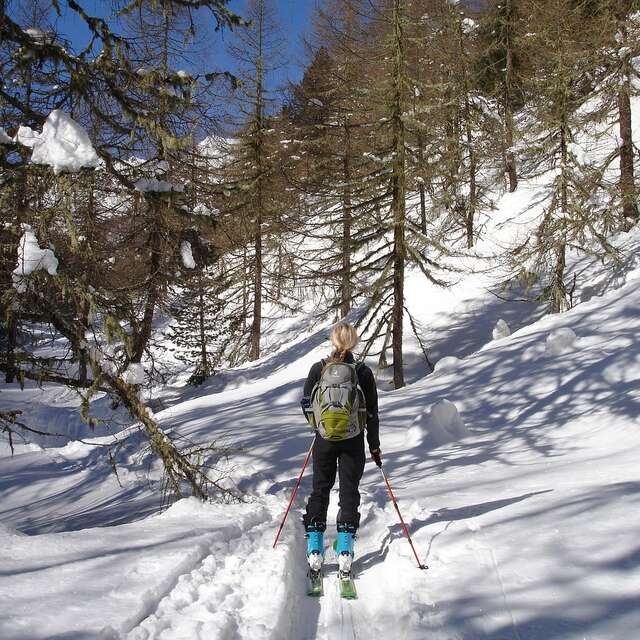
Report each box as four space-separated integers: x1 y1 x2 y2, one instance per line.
516 0 615 312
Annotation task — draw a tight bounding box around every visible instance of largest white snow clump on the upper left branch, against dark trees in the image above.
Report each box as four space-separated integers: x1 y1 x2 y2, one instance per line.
16 109 100 175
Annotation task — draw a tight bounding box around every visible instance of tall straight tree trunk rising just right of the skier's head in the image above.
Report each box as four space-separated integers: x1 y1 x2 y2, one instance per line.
391 0 406 389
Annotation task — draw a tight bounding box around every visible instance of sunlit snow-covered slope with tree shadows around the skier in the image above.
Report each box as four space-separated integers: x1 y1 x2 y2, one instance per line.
0 216 640 640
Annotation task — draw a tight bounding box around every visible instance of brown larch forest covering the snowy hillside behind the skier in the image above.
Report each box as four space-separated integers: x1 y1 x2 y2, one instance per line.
0 0 640 498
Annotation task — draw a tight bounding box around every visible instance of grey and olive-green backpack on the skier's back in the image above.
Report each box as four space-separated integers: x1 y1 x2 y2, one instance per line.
309 362 367 440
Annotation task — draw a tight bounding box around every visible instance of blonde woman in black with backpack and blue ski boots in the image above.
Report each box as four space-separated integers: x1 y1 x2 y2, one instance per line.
301 322 382 580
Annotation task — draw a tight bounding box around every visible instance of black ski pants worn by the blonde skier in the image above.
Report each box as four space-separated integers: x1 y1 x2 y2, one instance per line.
303 433 365 529
